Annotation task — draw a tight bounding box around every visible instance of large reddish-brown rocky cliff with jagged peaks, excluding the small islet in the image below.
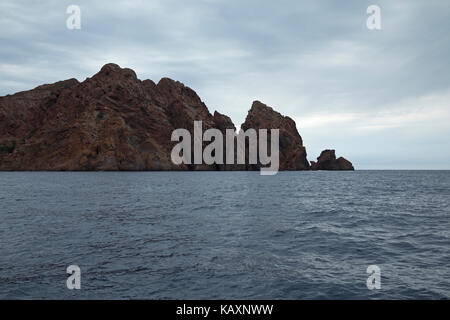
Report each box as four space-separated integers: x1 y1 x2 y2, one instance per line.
0 64 352 170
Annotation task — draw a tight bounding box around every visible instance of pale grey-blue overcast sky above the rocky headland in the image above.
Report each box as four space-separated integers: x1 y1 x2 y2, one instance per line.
0 0 450 169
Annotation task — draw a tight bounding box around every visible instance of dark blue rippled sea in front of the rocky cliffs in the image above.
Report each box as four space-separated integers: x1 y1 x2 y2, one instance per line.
0 171 450 299
